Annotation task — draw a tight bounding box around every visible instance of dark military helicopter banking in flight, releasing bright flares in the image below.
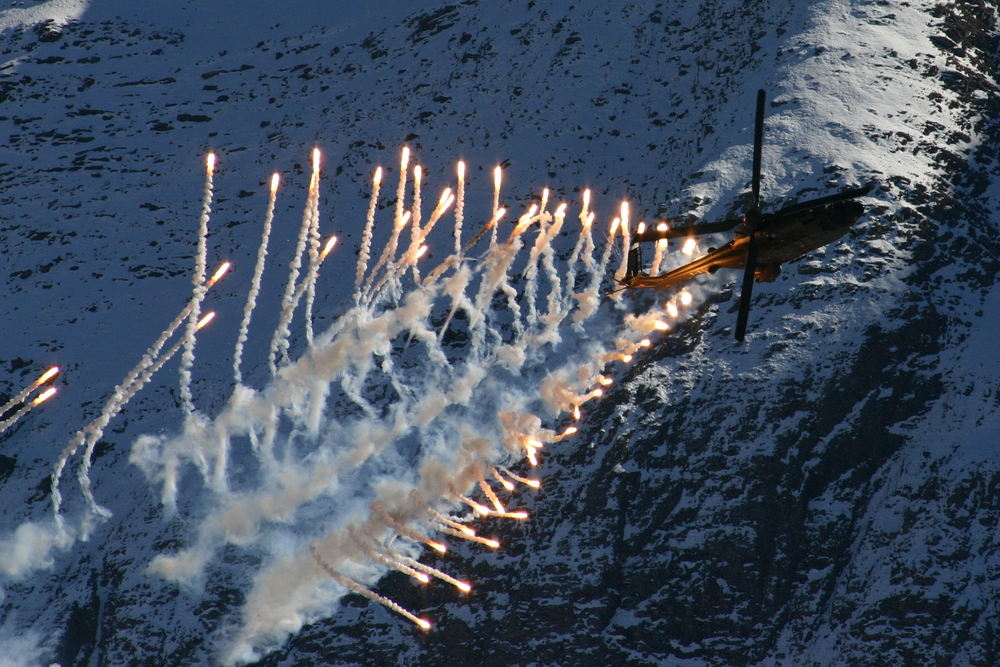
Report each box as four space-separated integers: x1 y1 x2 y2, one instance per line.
620 90 875 342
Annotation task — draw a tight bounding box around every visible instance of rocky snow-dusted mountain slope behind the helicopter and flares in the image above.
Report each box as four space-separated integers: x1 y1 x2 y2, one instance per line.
0 0 1000 664
